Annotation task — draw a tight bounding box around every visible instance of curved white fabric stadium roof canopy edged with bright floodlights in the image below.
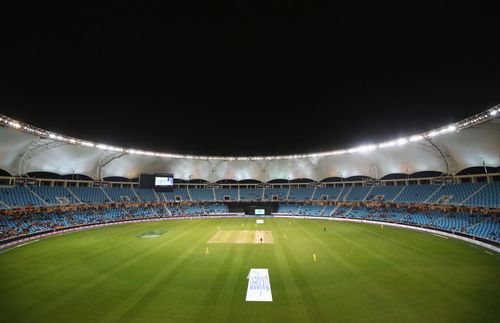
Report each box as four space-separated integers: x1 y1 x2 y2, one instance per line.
0 105 500 182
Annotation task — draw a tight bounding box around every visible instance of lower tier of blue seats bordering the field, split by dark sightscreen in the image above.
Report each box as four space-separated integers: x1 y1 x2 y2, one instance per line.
0 203 500 243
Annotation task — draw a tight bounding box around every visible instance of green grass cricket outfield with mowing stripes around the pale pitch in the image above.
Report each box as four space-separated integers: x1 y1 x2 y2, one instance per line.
0 218 500 323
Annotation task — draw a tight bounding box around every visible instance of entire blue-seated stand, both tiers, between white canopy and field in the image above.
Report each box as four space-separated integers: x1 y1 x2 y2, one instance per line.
0 182 500 242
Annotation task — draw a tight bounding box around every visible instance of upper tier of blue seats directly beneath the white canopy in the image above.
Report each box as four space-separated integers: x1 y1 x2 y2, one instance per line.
0 182 500 212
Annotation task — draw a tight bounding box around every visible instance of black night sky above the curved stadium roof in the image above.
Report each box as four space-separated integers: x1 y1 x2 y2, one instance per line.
0 2 500 156
